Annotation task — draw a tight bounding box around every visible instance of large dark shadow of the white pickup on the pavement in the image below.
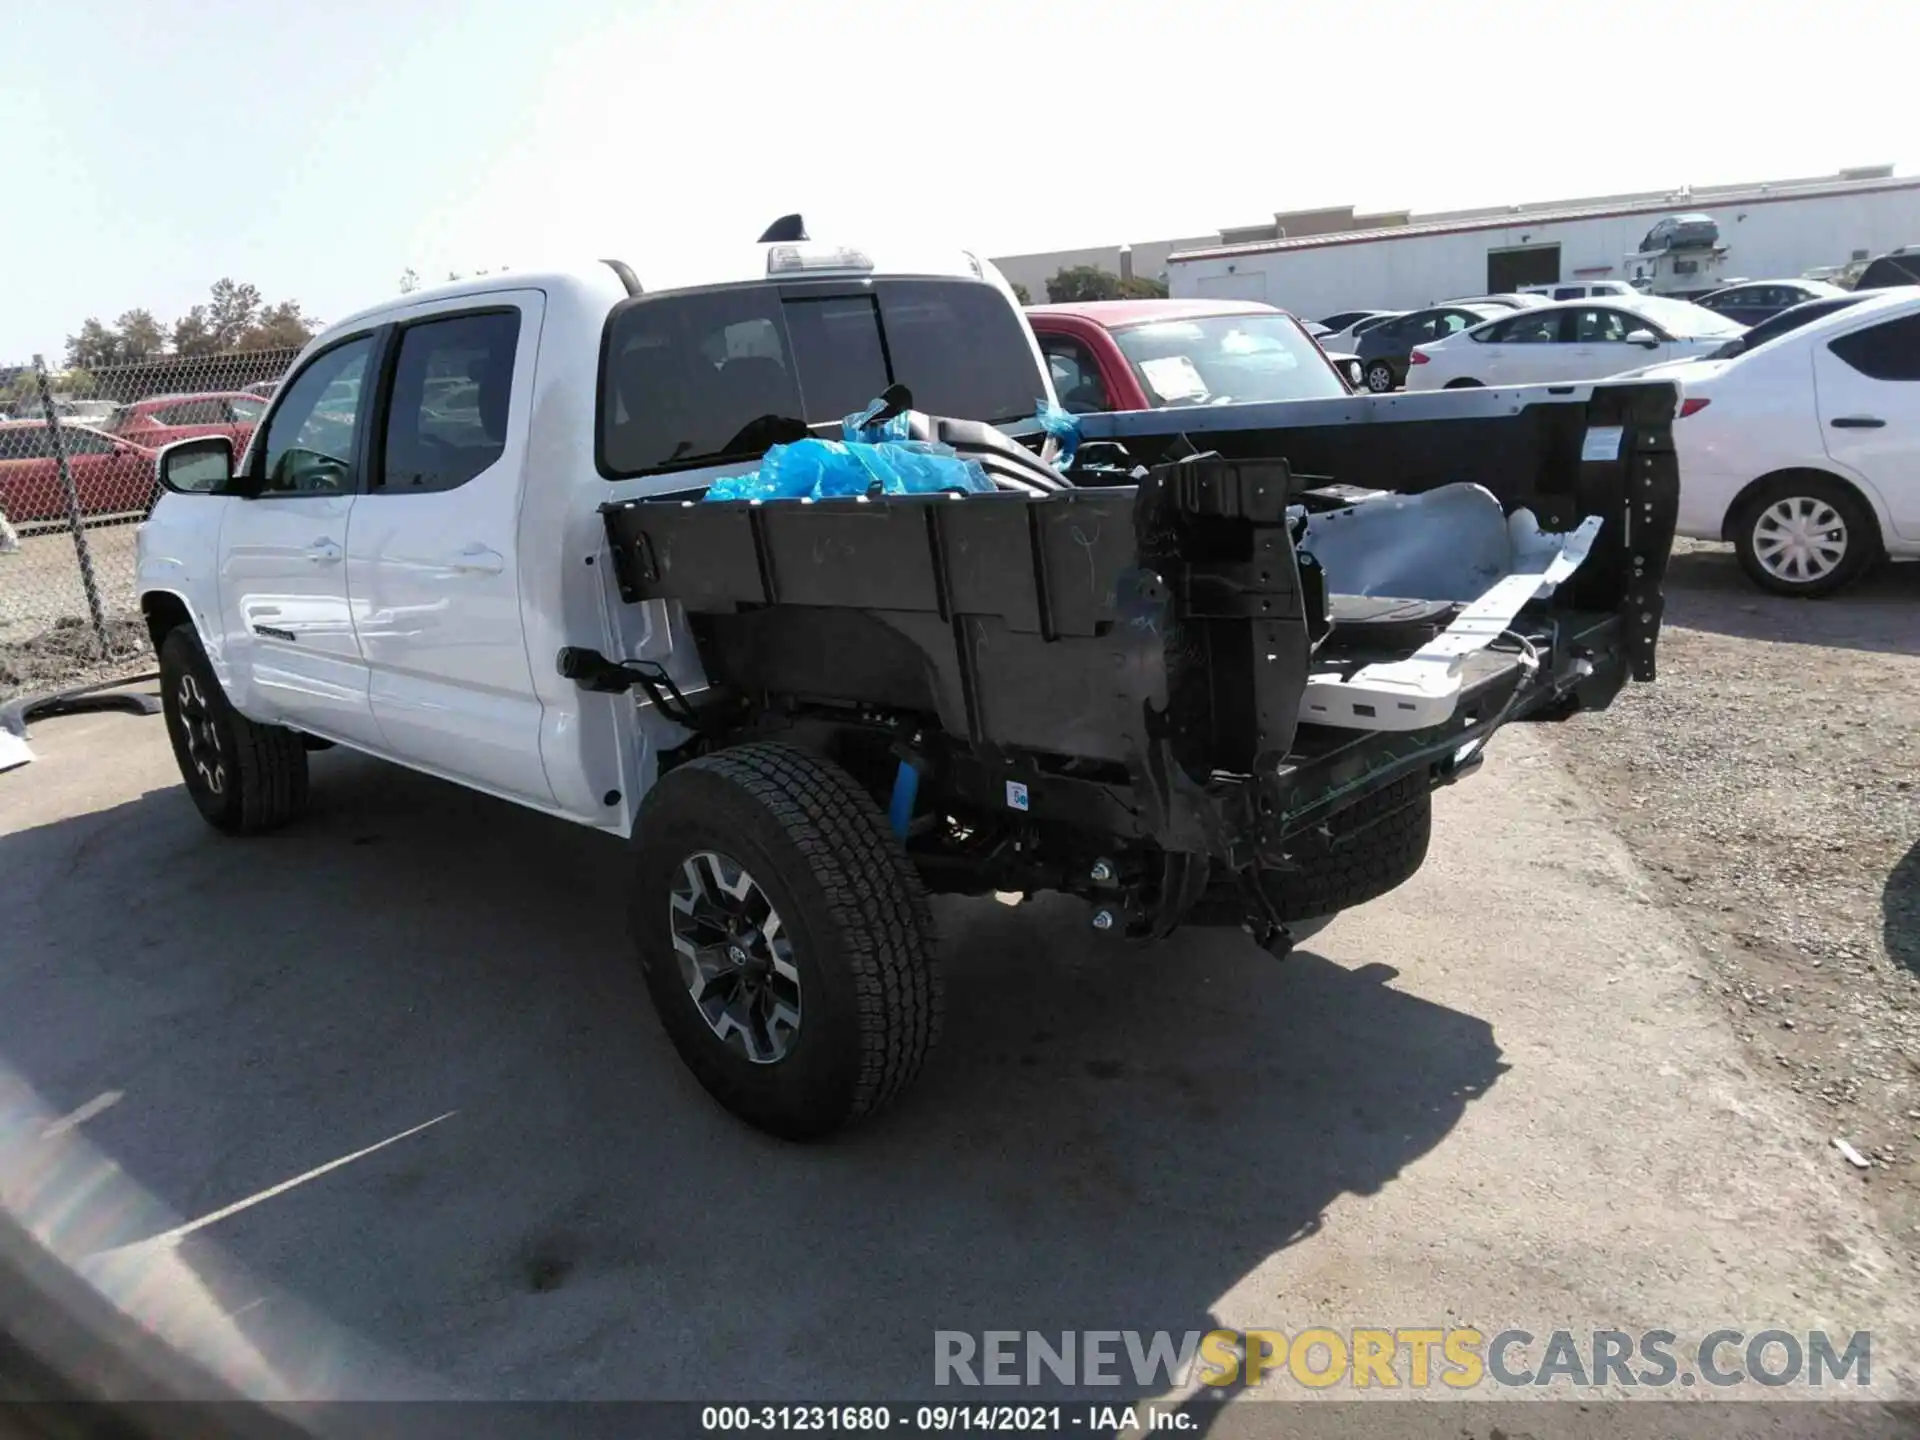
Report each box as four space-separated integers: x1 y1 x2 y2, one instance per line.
0 755 1505 1400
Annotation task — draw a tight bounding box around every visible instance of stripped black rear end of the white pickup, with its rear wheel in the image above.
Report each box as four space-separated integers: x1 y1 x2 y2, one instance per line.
591 384 1678 1135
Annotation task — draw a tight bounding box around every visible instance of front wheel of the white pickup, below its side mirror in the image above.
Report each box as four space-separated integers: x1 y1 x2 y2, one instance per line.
159 626 307 835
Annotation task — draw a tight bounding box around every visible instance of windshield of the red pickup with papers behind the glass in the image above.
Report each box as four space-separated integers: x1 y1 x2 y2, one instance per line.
1114 313 1348 409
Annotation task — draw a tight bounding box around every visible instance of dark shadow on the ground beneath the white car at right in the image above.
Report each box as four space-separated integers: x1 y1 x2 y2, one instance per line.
1665 545 1920 655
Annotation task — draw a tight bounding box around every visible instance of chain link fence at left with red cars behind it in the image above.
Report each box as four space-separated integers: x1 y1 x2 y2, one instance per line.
0 349 298 703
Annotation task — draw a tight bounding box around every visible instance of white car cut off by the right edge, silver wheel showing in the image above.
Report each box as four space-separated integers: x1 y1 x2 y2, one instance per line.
1644 286 1920 595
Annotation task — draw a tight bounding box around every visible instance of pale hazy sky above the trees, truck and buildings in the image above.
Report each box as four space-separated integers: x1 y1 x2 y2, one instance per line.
0 0 1920 363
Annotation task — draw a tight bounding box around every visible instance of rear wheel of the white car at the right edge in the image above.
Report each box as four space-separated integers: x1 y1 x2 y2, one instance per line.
1732 474 1882 597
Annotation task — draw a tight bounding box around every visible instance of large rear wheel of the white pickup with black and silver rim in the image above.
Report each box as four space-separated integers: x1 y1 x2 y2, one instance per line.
632 743 941 1140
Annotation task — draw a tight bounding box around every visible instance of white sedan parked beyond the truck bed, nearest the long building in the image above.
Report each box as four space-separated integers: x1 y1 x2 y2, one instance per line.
1405 296 1747 390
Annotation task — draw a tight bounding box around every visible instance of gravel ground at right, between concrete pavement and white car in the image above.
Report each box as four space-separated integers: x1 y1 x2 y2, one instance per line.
1553 540 1920 1263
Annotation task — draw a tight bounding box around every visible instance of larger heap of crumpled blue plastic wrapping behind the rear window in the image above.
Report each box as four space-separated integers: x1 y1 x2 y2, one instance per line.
703 399 995 499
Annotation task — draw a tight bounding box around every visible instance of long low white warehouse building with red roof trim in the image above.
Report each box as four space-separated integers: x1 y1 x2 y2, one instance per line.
1165 165 1920 315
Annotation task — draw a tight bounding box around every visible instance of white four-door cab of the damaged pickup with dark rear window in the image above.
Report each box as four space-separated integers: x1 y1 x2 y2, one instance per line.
138 242 1052 833
